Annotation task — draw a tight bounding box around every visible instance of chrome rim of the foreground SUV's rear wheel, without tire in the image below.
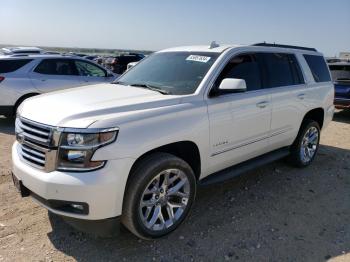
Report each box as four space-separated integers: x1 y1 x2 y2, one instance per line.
300 126 319 163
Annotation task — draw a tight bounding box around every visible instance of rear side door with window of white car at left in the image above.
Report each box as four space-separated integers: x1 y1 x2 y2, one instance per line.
30 58 83 93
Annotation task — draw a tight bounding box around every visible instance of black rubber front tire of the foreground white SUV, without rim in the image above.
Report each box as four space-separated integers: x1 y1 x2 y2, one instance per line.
121 153 196 239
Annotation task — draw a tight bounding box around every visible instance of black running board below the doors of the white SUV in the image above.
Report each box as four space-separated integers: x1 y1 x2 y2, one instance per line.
199 147 290 186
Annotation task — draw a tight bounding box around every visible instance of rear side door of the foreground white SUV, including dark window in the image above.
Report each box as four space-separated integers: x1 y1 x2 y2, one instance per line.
260 53 307 150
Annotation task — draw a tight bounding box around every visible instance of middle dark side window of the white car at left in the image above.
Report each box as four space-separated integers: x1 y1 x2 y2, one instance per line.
34 59 79 75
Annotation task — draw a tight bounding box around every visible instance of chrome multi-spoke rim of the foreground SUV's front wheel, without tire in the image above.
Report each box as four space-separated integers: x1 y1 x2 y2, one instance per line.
139 169 190 231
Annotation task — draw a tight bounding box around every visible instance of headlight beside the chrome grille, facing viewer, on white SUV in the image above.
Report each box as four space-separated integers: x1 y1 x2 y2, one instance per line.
57 130 118 171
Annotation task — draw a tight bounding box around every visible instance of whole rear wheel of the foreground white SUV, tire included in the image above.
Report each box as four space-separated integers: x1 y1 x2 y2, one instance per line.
290 120 320 167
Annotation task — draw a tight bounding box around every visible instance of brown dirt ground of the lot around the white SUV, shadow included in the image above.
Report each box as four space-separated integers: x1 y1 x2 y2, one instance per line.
0 111 350 261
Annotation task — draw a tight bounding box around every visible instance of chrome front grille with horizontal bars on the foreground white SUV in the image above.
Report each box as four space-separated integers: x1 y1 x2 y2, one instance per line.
16 118 57 172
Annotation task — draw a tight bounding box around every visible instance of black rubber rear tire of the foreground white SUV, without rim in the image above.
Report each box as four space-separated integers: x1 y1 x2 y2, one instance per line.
288 119 321 167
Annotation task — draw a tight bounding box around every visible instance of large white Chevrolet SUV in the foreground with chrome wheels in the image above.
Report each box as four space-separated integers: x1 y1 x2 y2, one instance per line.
12 44 334 238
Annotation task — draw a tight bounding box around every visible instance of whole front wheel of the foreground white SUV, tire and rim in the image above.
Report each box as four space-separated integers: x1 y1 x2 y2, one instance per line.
122 153 196 239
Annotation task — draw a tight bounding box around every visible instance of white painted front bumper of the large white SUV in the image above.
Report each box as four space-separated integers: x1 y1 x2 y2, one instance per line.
12 142 134 220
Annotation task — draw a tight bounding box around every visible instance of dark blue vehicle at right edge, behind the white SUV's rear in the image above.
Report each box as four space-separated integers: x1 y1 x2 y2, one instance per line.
328 61 350 109
